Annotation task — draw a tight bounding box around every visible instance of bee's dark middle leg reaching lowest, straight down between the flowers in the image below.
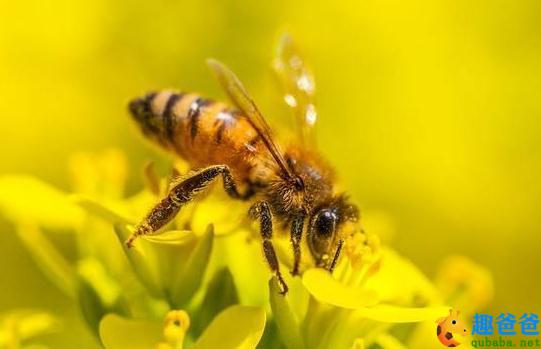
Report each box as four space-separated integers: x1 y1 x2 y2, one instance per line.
250 201 288 295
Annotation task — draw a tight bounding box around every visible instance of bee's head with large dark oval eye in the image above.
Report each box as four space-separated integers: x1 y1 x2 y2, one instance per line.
308 196 359 268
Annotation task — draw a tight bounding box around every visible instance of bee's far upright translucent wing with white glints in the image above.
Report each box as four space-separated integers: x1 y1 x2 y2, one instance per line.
273 35 317 145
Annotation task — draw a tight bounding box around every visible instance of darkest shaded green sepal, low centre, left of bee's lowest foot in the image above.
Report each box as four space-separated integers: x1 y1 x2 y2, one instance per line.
190 268 239 337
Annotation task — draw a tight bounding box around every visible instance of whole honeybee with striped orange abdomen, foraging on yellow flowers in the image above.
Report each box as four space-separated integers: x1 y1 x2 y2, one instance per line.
126 36 359 294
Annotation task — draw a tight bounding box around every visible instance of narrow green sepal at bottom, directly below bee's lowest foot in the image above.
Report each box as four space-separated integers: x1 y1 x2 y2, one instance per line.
269 277 304 349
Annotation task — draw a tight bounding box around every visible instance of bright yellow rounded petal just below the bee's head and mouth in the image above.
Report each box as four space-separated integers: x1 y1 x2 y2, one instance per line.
302 268 378 309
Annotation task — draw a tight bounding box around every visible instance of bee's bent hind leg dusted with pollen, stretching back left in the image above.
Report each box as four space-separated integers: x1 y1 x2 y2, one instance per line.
126 165 246 248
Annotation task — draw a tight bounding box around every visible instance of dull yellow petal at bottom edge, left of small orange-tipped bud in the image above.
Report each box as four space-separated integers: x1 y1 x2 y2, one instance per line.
99 314 163 349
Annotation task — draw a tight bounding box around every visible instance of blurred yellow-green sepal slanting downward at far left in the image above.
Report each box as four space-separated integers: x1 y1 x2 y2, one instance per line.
16 224 77 298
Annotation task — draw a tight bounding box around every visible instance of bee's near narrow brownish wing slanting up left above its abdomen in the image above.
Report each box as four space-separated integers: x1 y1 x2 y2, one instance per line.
207 59 295 179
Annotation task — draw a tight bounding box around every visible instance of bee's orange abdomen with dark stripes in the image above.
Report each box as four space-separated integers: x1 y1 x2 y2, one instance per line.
130 91 262 179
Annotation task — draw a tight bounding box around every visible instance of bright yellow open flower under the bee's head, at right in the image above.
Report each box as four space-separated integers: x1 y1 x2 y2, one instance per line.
270 226 448 348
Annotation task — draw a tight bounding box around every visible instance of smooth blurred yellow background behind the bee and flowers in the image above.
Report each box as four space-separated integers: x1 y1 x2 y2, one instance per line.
0 0 541 348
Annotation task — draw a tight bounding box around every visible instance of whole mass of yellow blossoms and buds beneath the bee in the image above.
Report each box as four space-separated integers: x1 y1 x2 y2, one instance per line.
0 150 492 349
